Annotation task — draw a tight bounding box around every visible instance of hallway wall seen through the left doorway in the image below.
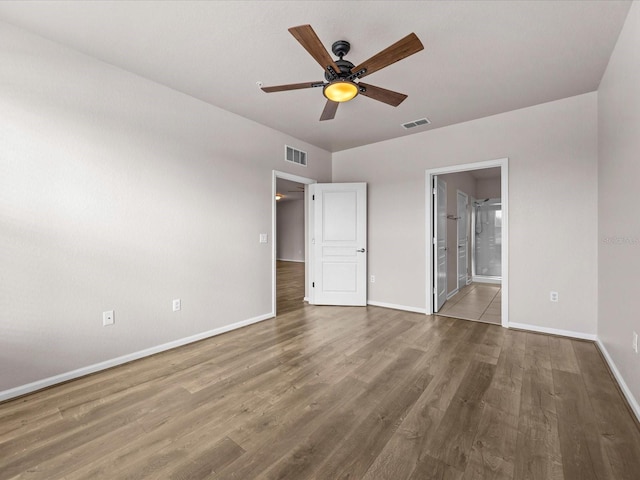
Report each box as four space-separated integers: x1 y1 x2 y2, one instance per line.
276 198 304 262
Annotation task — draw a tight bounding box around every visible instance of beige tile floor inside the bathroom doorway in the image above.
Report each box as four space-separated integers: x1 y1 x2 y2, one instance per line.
438 283 502 325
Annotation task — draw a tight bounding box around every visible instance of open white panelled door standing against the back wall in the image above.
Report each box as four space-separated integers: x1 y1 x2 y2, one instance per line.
309 183 367 306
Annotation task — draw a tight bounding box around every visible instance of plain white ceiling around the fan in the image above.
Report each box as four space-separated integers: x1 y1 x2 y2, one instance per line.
0 0 631 152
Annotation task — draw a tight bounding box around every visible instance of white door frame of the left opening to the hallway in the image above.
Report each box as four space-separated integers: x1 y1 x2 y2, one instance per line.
271 170 318 317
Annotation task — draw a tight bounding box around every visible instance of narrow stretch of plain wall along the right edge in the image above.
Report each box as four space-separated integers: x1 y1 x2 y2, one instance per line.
598 2 640 408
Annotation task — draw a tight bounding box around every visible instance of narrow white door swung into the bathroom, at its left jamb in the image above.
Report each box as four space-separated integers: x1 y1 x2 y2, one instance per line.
433 177 447 312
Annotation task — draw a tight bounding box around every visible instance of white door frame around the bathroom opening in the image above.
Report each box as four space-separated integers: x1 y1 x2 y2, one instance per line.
425 158 509 328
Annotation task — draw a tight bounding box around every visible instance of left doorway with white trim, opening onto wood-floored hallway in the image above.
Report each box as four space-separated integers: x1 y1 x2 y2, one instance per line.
271 170 316 316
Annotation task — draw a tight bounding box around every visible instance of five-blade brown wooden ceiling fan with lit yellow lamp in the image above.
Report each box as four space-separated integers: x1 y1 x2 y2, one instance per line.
262 25 424 121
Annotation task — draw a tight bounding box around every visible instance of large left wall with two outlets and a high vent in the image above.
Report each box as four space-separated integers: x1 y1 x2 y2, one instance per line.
0 24 331 393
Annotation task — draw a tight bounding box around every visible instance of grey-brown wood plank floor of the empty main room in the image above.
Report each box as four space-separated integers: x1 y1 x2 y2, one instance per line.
0 305 640 480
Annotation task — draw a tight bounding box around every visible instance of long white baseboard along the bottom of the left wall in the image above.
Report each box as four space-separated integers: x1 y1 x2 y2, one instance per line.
0 312 274 402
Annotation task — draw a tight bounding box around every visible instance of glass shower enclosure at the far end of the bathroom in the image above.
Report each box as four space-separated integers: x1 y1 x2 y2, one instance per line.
471 198 502 283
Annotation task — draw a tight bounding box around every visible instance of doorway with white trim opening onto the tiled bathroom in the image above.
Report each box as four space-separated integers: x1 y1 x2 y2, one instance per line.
426 159 509 327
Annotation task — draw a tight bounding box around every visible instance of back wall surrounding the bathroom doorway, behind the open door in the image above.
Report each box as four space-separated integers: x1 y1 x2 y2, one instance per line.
333 93 597 335
